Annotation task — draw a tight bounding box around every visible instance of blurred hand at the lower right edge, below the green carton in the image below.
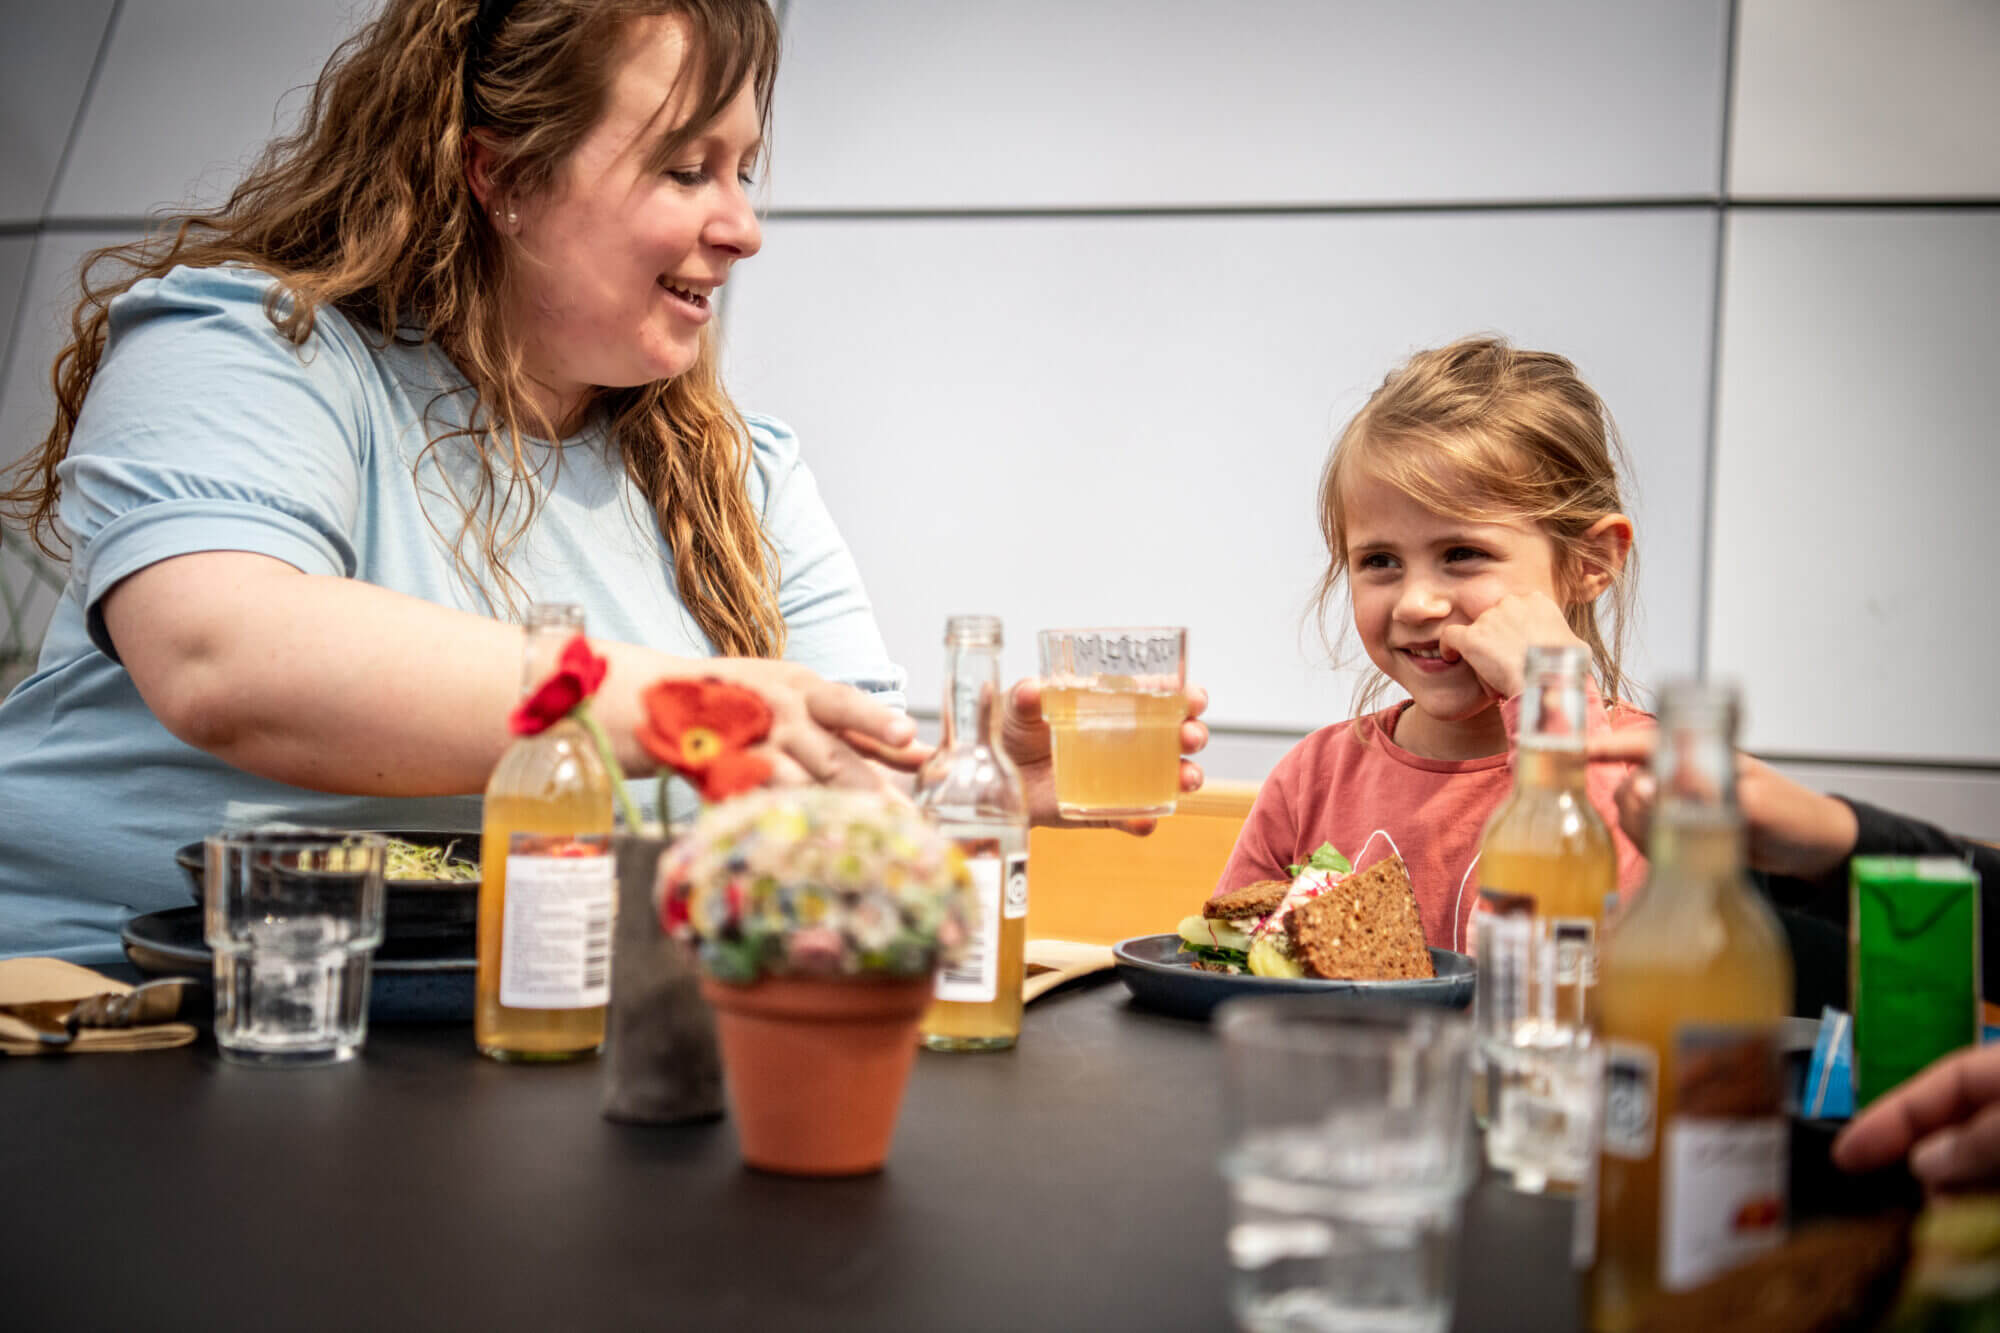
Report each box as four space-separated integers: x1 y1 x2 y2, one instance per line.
1834 1047 2000 1191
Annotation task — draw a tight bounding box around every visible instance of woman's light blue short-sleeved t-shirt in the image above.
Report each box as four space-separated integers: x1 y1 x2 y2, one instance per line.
0 268 904 963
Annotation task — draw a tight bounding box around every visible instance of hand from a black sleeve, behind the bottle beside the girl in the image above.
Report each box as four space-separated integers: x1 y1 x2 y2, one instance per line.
1586 727 1860 879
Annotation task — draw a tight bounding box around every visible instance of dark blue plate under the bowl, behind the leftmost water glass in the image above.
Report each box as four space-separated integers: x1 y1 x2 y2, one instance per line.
118 907 476 1023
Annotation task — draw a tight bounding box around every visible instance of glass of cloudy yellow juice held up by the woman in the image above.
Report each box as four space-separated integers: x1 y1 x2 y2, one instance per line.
1038 628 1188 819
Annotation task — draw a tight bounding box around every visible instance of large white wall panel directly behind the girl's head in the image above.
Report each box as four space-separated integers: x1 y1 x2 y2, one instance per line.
726 208 1714 728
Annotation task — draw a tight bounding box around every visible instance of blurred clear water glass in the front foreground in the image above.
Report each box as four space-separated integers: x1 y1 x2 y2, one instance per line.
1218 995 1478 1333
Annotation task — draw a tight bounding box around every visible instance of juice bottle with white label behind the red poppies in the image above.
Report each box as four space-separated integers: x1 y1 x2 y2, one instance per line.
472 604 616 1061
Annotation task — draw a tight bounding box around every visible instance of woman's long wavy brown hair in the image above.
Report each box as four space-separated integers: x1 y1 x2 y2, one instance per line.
0 0 784 656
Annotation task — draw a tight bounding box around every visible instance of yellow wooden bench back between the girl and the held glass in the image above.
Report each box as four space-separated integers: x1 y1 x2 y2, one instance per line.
1028 783 1258 945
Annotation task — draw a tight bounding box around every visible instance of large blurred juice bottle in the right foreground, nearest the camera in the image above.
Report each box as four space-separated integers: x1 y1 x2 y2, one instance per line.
1578 683 1792 1333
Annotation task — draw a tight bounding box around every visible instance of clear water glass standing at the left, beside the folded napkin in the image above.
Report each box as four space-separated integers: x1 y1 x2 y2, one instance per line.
202 829 388 1065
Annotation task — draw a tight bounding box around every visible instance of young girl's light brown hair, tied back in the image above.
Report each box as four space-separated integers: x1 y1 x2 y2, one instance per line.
1312 336 1638 717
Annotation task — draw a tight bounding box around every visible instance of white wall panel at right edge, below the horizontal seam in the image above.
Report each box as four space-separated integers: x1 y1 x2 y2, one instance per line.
1710 208 2000 763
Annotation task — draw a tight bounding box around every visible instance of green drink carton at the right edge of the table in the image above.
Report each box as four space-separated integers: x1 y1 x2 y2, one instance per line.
1848 857 1980 1109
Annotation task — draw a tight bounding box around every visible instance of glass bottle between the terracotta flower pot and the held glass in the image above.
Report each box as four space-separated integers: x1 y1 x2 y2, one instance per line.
916 616 1028 1051
